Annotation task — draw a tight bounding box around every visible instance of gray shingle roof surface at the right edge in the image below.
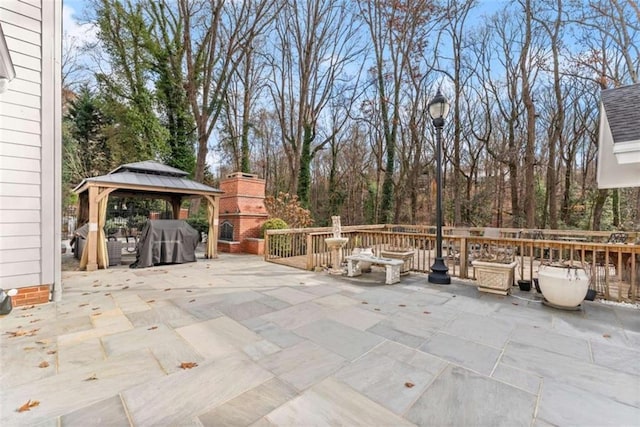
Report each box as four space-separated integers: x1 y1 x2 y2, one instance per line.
602 83 640 143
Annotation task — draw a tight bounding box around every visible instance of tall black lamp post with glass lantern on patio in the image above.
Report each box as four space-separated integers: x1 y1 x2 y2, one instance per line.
429 89 451 285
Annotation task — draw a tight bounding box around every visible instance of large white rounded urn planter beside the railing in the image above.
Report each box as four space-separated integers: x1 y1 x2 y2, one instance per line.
538 265 589 310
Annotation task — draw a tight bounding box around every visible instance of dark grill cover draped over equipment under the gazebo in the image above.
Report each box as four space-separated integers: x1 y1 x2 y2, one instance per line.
129 219 200 268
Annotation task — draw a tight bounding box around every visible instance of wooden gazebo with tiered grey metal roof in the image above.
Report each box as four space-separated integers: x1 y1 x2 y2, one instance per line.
73 160 223 271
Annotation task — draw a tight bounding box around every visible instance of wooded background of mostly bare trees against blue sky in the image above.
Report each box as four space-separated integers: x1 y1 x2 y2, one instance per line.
63 0 640 230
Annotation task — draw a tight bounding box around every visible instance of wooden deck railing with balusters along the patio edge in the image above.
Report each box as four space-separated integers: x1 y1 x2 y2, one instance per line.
265 225 640 301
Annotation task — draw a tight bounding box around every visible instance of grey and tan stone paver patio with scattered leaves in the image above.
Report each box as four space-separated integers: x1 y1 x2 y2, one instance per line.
0 254 640 426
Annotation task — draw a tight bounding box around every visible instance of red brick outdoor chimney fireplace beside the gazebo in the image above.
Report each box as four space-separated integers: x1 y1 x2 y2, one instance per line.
218 172 269 254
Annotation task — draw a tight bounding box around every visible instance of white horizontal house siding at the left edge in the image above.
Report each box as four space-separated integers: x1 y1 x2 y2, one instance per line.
0 0 62 300
